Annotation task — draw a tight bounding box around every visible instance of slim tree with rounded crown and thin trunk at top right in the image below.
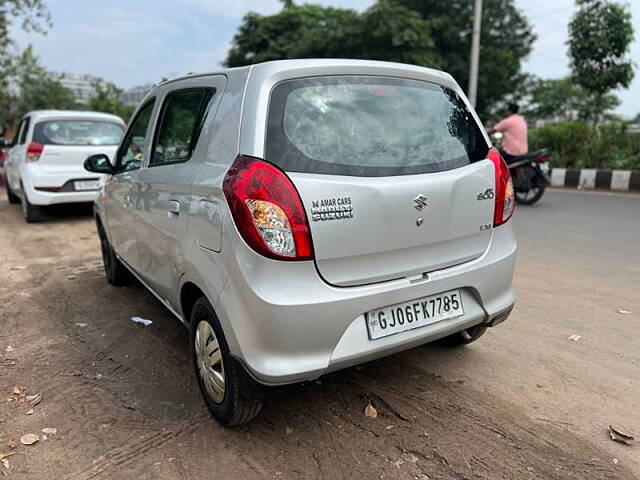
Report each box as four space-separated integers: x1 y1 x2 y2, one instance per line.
568 0 634 128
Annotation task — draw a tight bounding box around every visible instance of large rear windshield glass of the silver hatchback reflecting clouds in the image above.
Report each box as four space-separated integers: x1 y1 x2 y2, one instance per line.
266 76 488 177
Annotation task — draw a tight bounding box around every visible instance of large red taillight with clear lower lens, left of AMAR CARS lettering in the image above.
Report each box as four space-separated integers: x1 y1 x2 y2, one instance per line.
222 155 313 260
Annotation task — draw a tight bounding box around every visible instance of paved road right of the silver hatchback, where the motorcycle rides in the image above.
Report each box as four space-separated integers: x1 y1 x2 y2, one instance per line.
408 190 640 468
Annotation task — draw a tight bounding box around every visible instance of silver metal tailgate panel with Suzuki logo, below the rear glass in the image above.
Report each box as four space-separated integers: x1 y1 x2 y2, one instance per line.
292 162 494 286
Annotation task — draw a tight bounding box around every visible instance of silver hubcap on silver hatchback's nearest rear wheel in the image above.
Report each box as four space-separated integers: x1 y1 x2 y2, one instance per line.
195 321 225 403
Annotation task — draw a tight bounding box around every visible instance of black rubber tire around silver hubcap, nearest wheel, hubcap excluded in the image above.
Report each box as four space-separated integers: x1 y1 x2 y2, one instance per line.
191 297 262 427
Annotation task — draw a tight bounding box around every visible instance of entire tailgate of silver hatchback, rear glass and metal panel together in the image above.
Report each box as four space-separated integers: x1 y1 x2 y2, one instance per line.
265 76 496 286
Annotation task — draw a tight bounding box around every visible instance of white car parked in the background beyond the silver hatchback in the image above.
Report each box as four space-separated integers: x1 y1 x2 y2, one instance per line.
5 110 125 222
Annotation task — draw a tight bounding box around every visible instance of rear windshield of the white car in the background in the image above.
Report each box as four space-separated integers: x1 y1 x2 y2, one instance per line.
33 120 124 145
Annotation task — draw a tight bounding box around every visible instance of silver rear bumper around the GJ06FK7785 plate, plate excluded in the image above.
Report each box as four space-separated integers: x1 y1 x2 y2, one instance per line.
215 222 516 385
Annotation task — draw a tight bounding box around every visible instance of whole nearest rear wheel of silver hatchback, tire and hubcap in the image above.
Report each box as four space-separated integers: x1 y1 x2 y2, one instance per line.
191 297 262 427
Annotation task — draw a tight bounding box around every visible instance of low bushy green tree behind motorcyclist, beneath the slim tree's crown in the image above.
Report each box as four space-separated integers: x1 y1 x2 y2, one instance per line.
524 78 620 122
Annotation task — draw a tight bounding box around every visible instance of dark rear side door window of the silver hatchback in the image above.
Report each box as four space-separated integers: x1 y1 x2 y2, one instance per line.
149 89 214 166
